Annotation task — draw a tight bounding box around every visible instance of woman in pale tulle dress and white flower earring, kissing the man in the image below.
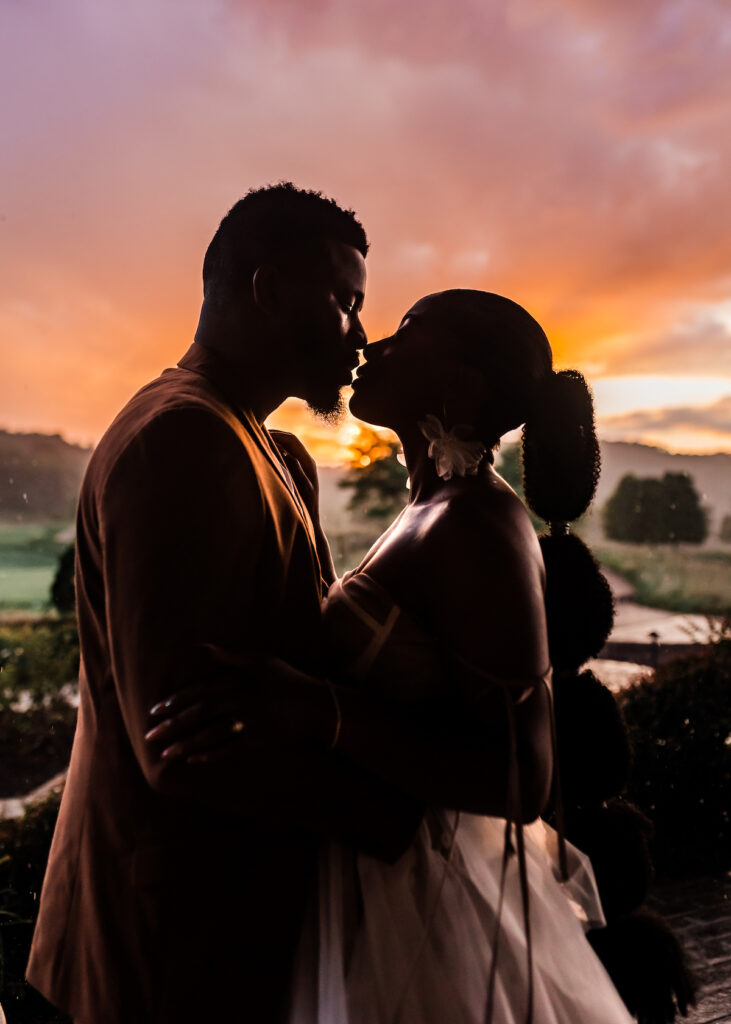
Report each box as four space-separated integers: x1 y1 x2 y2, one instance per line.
145 291 631 1024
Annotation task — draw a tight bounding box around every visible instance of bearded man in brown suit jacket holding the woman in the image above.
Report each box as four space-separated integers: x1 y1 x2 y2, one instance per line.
28 183 418 1024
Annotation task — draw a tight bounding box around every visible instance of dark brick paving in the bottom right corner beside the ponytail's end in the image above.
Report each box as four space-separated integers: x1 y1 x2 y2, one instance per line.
649 871 731 1024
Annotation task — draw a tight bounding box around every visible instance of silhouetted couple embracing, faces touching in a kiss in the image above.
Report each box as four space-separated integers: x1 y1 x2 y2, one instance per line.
28 183 630 1024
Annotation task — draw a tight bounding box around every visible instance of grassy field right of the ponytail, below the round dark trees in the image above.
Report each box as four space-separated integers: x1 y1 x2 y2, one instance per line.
593 542 731 614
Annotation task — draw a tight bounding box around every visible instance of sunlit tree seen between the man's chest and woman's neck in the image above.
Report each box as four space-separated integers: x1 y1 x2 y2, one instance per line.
338 427 409 520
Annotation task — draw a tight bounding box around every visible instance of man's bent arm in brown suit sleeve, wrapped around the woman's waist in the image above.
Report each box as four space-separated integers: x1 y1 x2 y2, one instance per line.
99 409 419 857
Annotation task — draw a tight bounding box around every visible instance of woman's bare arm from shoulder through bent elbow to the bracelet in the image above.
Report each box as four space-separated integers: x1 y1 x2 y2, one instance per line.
315 493 553 820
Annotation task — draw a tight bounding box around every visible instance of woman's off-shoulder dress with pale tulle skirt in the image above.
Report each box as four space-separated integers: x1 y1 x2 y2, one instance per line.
289 571 633 1024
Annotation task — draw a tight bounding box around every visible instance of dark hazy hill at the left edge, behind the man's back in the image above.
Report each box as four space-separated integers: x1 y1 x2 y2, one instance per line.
0 430 91 522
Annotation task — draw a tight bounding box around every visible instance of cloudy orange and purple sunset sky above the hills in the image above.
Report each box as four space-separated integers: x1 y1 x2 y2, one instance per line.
0 0 731 461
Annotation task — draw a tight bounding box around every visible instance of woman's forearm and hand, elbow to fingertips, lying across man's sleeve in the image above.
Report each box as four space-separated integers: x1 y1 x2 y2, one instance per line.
147 658 548 821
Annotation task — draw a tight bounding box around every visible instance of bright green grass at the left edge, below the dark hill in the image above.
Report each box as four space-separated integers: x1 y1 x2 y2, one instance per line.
0 523 69 611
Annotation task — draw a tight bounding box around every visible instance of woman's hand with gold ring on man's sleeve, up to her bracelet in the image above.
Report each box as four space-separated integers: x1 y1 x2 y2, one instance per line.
144 646 332 764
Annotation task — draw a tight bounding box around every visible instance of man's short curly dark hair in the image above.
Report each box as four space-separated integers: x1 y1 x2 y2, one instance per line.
203 181 369 296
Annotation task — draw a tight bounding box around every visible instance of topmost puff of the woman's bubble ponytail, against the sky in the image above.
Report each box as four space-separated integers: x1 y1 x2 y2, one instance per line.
523 370 601 522
